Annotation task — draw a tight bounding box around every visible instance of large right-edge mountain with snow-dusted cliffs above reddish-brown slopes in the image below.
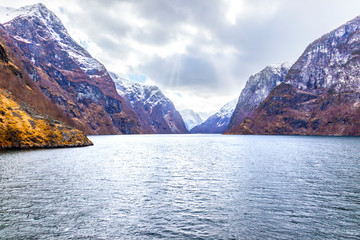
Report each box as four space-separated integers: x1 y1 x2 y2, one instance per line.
228 17 360 136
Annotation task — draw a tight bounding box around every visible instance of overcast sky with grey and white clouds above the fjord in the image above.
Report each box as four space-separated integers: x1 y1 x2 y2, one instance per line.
0 0 360 113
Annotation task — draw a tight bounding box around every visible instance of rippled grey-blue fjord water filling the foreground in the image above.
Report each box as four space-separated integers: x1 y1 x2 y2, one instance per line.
0 135 360 239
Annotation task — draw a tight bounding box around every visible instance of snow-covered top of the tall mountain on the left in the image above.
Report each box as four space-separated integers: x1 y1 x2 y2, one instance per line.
0 3 106 76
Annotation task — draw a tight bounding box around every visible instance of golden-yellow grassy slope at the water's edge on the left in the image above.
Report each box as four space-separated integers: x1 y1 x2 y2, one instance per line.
0 89 92 149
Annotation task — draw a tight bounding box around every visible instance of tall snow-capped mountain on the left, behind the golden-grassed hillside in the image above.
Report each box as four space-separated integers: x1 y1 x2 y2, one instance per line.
0 3 144 134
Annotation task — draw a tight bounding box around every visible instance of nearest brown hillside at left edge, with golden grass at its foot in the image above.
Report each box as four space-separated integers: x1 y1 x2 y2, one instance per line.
0 30 92 149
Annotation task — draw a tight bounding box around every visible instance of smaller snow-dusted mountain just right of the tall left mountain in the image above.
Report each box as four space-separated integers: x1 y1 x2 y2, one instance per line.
110 73 189 134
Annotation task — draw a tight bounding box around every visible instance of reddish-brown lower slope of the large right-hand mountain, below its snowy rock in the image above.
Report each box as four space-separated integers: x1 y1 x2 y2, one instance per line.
228 83 360 136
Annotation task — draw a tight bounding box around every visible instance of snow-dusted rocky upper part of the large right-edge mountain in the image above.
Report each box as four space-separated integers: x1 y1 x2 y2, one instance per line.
285 14 360 93
